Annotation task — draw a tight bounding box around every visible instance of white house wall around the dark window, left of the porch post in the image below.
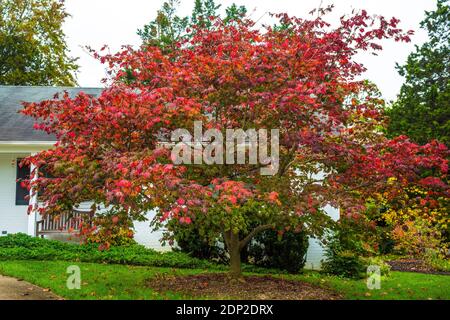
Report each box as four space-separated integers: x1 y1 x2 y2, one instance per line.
0 153 28 235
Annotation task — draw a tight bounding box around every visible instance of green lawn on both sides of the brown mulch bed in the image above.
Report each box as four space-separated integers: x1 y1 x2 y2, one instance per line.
0 260 450 299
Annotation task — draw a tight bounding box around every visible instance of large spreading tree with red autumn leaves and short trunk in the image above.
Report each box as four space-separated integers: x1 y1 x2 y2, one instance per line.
23 11 448 276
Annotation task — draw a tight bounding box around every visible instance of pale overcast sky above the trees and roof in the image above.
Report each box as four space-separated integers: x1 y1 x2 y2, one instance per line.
64 0 436 100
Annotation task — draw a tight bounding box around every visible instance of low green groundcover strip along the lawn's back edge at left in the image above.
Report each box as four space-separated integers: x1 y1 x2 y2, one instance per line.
0 234 217 268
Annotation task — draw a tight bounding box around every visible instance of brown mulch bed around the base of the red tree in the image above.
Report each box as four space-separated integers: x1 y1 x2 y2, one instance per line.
147 273 342 300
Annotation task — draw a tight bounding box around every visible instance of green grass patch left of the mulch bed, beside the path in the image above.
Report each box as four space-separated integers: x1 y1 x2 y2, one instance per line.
0 261 203 300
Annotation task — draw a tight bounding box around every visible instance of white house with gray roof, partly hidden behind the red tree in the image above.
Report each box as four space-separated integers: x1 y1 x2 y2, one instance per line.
0 86 339 269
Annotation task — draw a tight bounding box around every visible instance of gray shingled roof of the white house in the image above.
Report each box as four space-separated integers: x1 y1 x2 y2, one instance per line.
0 86 102 142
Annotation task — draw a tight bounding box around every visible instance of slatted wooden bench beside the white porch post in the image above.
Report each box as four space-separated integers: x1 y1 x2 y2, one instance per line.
36 209 93 237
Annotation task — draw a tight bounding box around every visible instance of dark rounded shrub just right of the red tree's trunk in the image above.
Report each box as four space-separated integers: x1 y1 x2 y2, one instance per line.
247 230 308 273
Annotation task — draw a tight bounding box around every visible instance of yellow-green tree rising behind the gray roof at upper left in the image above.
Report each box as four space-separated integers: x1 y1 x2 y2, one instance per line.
0 0 78 86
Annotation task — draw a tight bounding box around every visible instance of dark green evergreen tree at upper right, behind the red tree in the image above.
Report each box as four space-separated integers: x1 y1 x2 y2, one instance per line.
387 0 450 146
